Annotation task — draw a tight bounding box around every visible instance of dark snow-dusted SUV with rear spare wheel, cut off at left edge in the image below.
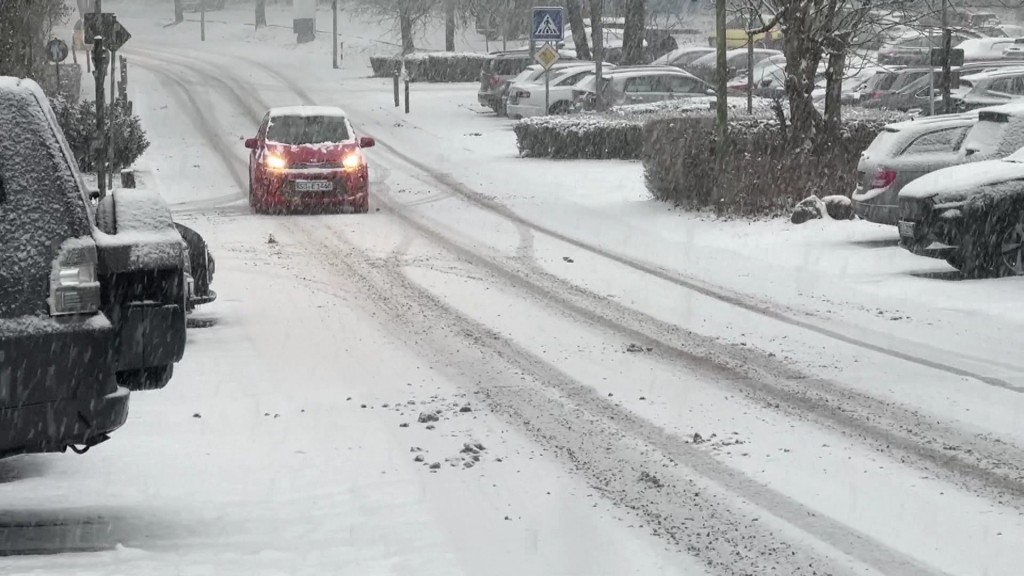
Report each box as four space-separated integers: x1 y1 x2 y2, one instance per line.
0 77 185 456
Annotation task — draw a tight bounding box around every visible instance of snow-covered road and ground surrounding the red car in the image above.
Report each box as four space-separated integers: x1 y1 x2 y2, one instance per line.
6 0 1024 576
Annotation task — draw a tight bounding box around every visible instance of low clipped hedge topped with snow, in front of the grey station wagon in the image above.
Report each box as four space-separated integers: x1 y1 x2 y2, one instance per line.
512 97 768 160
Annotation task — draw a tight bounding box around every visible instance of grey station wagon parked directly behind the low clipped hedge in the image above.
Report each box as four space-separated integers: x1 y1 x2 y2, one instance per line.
572 67 715 110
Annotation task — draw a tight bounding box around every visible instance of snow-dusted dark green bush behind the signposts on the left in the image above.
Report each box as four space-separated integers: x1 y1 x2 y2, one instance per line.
50 98 150 172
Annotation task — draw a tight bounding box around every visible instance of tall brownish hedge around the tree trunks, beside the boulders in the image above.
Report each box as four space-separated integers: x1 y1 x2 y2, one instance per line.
643 112 896 215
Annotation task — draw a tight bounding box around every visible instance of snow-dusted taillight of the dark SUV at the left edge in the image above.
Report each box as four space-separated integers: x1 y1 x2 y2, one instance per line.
49 239 99 316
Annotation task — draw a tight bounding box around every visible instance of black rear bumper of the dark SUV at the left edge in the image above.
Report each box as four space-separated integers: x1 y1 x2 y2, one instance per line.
0 318 128 457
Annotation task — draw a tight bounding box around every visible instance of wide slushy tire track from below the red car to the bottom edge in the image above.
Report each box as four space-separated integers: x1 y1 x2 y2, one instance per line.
282 219 943 576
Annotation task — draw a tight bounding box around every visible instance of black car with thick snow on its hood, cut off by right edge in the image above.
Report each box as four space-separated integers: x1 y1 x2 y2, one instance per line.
898 104 1024 276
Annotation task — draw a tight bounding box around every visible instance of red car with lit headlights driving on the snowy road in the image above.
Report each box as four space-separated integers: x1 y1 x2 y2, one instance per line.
246 107 376 213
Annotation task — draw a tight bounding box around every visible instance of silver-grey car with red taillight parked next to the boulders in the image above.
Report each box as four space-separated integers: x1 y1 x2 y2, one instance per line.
852 112 978 225
